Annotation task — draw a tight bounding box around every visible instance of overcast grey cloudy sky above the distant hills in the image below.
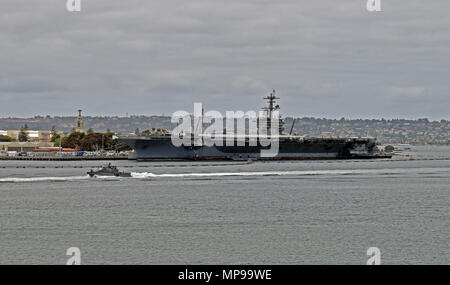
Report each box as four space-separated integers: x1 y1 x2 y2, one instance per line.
0 0 450 119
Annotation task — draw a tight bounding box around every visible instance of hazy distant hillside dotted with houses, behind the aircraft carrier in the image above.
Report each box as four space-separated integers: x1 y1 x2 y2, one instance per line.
0 116 450 145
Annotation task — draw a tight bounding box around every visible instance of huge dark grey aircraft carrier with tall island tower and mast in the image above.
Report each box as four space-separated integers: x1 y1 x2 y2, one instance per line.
119 91 391 161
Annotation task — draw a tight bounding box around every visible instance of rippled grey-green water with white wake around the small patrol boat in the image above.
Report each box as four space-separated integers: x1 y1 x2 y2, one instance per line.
0 147 450 264
